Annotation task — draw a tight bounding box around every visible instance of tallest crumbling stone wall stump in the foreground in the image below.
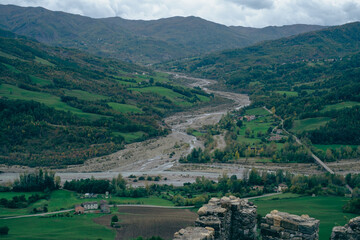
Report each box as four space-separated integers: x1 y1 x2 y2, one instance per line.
195 196 257 240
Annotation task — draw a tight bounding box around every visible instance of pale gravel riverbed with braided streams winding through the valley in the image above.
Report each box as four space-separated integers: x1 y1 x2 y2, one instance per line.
0 74 250 186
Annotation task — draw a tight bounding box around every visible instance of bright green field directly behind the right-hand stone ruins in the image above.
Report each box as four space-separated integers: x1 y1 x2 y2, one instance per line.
251 194 356 240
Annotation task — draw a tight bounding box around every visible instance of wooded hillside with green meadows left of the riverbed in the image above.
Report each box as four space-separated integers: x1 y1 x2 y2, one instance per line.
0 31 212 166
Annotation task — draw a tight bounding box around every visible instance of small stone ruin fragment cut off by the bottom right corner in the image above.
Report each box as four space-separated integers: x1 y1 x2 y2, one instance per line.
331 217 360 240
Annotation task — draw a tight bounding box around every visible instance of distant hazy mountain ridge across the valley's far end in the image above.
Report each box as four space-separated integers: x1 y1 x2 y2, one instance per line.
0 5 325 64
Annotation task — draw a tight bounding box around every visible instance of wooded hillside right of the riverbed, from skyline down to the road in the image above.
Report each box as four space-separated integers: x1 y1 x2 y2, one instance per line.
166 22 360 148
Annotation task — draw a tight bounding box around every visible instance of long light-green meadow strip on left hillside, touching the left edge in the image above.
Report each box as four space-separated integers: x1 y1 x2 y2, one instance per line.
0 84 106 120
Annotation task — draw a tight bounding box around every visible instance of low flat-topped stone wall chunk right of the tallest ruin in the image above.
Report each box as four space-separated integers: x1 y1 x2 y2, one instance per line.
260 210 320 240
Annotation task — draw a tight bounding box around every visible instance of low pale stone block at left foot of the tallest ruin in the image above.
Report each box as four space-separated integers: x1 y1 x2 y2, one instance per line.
174 227 215 240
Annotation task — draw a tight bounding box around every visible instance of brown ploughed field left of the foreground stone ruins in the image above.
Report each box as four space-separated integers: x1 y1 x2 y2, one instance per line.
94 206 197 240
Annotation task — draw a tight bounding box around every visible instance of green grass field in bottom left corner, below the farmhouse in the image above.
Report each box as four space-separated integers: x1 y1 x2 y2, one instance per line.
0 214 115 240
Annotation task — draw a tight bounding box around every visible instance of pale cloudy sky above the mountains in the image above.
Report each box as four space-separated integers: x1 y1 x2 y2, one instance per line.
0 0 360 27
